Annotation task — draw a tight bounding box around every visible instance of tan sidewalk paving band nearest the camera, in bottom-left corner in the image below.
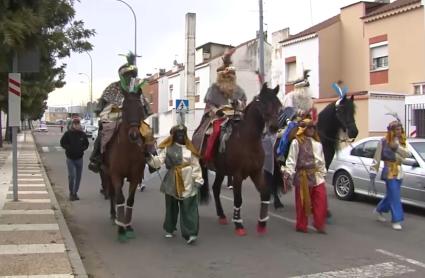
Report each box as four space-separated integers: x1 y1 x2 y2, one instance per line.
0 253 72 276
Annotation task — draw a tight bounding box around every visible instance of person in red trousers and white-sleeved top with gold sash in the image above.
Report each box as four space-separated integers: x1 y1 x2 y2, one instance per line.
283 118 327 233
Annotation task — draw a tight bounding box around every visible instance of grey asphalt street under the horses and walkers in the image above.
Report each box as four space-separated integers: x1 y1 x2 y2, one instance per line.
34 127 425 278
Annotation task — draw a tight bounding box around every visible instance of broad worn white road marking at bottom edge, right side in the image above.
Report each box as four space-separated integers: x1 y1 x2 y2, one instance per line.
291 262 415 278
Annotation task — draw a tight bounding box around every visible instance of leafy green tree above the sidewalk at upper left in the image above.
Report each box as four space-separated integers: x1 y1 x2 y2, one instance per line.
0 0 95 143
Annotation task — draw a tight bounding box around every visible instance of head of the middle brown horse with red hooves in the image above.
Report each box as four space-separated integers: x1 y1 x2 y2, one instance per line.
256 83 282 128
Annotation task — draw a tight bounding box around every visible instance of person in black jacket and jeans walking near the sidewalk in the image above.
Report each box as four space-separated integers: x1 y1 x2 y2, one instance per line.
60 118 89 201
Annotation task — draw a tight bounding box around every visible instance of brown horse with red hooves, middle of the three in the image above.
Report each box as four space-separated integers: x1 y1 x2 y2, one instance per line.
201 84 282 236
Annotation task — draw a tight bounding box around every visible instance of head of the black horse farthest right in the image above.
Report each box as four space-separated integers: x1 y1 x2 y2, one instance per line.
335 95 359 139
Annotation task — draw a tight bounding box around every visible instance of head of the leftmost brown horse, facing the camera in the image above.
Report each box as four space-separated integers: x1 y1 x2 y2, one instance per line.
122 90 145 143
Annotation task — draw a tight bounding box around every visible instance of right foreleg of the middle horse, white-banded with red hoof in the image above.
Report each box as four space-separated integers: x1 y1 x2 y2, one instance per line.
250 170 270 235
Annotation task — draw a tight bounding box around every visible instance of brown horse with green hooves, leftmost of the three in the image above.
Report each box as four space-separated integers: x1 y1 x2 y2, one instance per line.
102 93 145 241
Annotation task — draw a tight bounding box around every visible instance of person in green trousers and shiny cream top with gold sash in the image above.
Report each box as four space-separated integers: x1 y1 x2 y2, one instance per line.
151 124 204 244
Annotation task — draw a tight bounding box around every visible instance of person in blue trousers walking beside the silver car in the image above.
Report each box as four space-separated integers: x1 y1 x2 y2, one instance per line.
370 120 410 230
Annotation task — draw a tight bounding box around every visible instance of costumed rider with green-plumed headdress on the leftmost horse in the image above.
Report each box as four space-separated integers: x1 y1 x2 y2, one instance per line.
88 52 154 173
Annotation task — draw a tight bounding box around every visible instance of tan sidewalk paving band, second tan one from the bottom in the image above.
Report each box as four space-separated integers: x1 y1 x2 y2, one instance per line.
0 231 64 245
